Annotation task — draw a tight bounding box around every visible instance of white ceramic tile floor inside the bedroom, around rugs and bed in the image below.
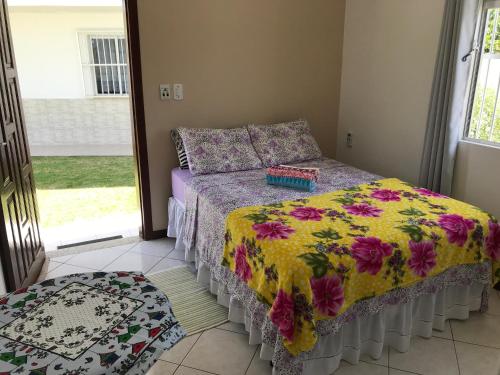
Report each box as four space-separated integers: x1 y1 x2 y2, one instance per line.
41 239 500 375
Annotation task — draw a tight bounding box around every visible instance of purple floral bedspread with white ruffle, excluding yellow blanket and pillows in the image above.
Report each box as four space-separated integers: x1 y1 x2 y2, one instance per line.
169 158 491 374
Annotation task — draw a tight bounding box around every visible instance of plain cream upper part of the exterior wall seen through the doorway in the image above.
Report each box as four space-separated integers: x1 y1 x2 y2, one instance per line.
9 6 124 99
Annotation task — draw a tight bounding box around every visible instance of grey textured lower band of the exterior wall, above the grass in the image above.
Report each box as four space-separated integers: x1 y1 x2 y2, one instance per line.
23 98 132 156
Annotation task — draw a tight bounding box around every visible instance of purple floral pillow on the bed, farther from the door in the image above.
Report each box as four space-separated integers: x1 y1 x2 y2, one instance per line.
248 120 321 167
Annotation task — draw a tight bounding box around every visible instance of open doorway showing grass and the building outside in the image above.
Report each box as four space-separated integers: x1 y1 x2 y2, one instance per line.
8 0 141 251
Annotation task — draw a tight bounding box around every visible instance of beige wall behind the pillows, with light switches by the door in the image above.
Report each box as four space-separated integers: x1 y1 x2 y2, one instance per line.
139 0 346 230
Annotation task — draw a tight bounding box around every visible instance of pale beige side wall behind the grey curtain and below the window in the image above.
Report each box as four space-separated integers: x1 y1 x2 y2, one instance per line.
337 0 500 217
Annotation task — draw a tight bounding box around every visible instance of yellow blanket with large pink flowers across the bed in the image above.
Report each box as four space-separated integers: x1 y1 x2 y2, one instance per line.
223 179 500 355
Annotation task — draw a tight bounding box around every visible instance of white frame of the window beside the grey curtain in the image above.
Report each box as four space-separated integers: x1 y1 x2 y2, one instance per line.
462 0 500 148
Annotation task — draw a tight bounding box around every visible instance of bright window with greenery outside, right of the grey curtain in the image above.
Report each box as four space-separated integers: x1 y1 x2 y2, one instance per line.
465 1 500 144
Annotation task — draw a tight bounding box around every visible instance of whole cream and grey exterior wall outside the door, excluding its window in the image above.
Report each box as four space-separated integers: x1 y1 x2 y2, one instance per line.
9 6 132 156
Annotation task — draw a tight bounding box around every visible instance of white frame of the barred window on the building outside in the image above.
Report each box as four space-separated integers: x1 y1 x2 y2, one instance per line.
77 30 130 98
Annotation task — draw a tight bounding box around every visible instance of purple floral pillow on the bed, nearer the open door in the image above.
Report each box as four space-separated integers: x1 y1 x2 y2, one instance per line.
179 128 262 175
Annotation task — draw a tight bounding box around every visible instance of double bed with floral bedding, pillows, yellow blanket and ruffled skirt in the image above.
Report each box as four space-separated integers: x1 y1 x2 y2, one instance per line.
169 120 500 374
